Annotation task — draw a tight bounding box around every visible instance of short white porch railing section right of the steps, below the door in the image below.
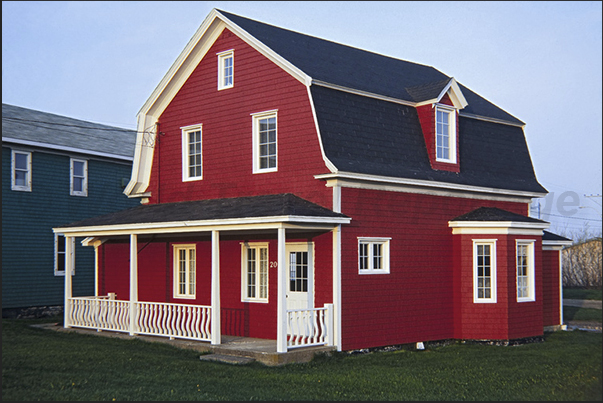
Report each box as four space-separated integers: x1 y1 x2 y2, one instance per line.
287 304 333 348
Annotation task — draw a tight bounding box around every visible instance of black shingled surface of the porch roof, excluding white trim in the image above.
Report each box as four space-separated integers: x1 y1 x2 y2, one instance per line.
57 193 347 228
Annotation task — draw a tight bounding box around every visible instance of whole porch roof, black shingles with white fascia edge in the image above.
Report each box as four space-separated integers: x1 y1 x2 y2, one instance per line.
53 193 351 236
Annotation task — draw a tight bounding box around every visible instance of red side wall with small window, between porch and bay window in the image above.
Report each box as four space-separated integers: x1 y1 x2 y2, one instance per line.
341 188 527 350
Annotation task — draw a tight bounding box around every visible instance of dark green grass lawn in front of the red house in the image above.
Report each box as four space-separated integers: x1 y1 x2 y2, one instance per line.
2 319 602 401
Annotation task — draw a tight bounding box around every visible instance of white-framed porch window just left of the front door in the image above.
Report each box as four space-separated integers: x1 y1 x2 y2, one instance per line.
241 243 268 302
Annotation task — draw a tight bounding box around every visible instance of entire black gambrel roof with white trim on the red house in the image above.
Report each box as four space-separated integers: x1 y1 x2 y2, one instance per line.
125 9 547 197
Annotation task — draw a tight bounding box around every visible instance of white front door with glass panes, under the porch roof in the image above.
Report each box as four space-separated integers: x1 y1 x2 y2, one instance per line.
285 242 314 309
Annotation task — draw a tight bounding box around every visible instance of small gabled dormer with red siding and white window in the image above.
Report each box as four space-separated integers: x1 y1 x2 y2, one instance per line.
406 78 467 172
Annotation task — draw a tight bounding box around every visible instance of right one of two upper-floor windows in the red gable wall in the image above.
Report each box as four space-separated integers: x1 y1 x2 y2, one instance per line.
252 111 277 173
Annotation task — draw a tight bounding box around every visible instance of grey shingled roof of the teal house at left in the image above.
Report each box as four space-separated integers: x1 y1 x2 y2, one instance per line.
2 103 136 161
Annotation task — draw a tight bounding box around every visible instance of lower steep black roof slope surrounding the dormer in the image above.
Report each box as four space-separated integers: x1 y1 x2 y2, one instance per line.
311 86 546 193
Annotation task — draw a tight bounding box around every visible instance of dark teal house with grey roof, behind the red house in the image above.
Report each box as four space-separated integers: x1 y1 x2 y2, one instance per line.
2 103 139 317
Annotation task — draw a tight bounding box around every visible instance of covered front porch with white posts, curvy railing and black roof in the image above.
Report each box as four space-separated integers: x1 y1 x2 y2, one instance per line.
53 194 350 354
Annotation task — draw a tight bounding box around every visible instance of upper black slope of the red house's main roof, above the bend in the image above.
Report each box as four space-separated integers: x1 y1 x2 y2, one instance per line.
217 10 524 125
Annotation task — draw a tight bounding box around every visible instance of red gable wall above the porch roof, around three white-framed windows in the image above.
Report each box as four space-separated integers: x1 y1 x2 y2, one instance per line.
148 30 332 207
